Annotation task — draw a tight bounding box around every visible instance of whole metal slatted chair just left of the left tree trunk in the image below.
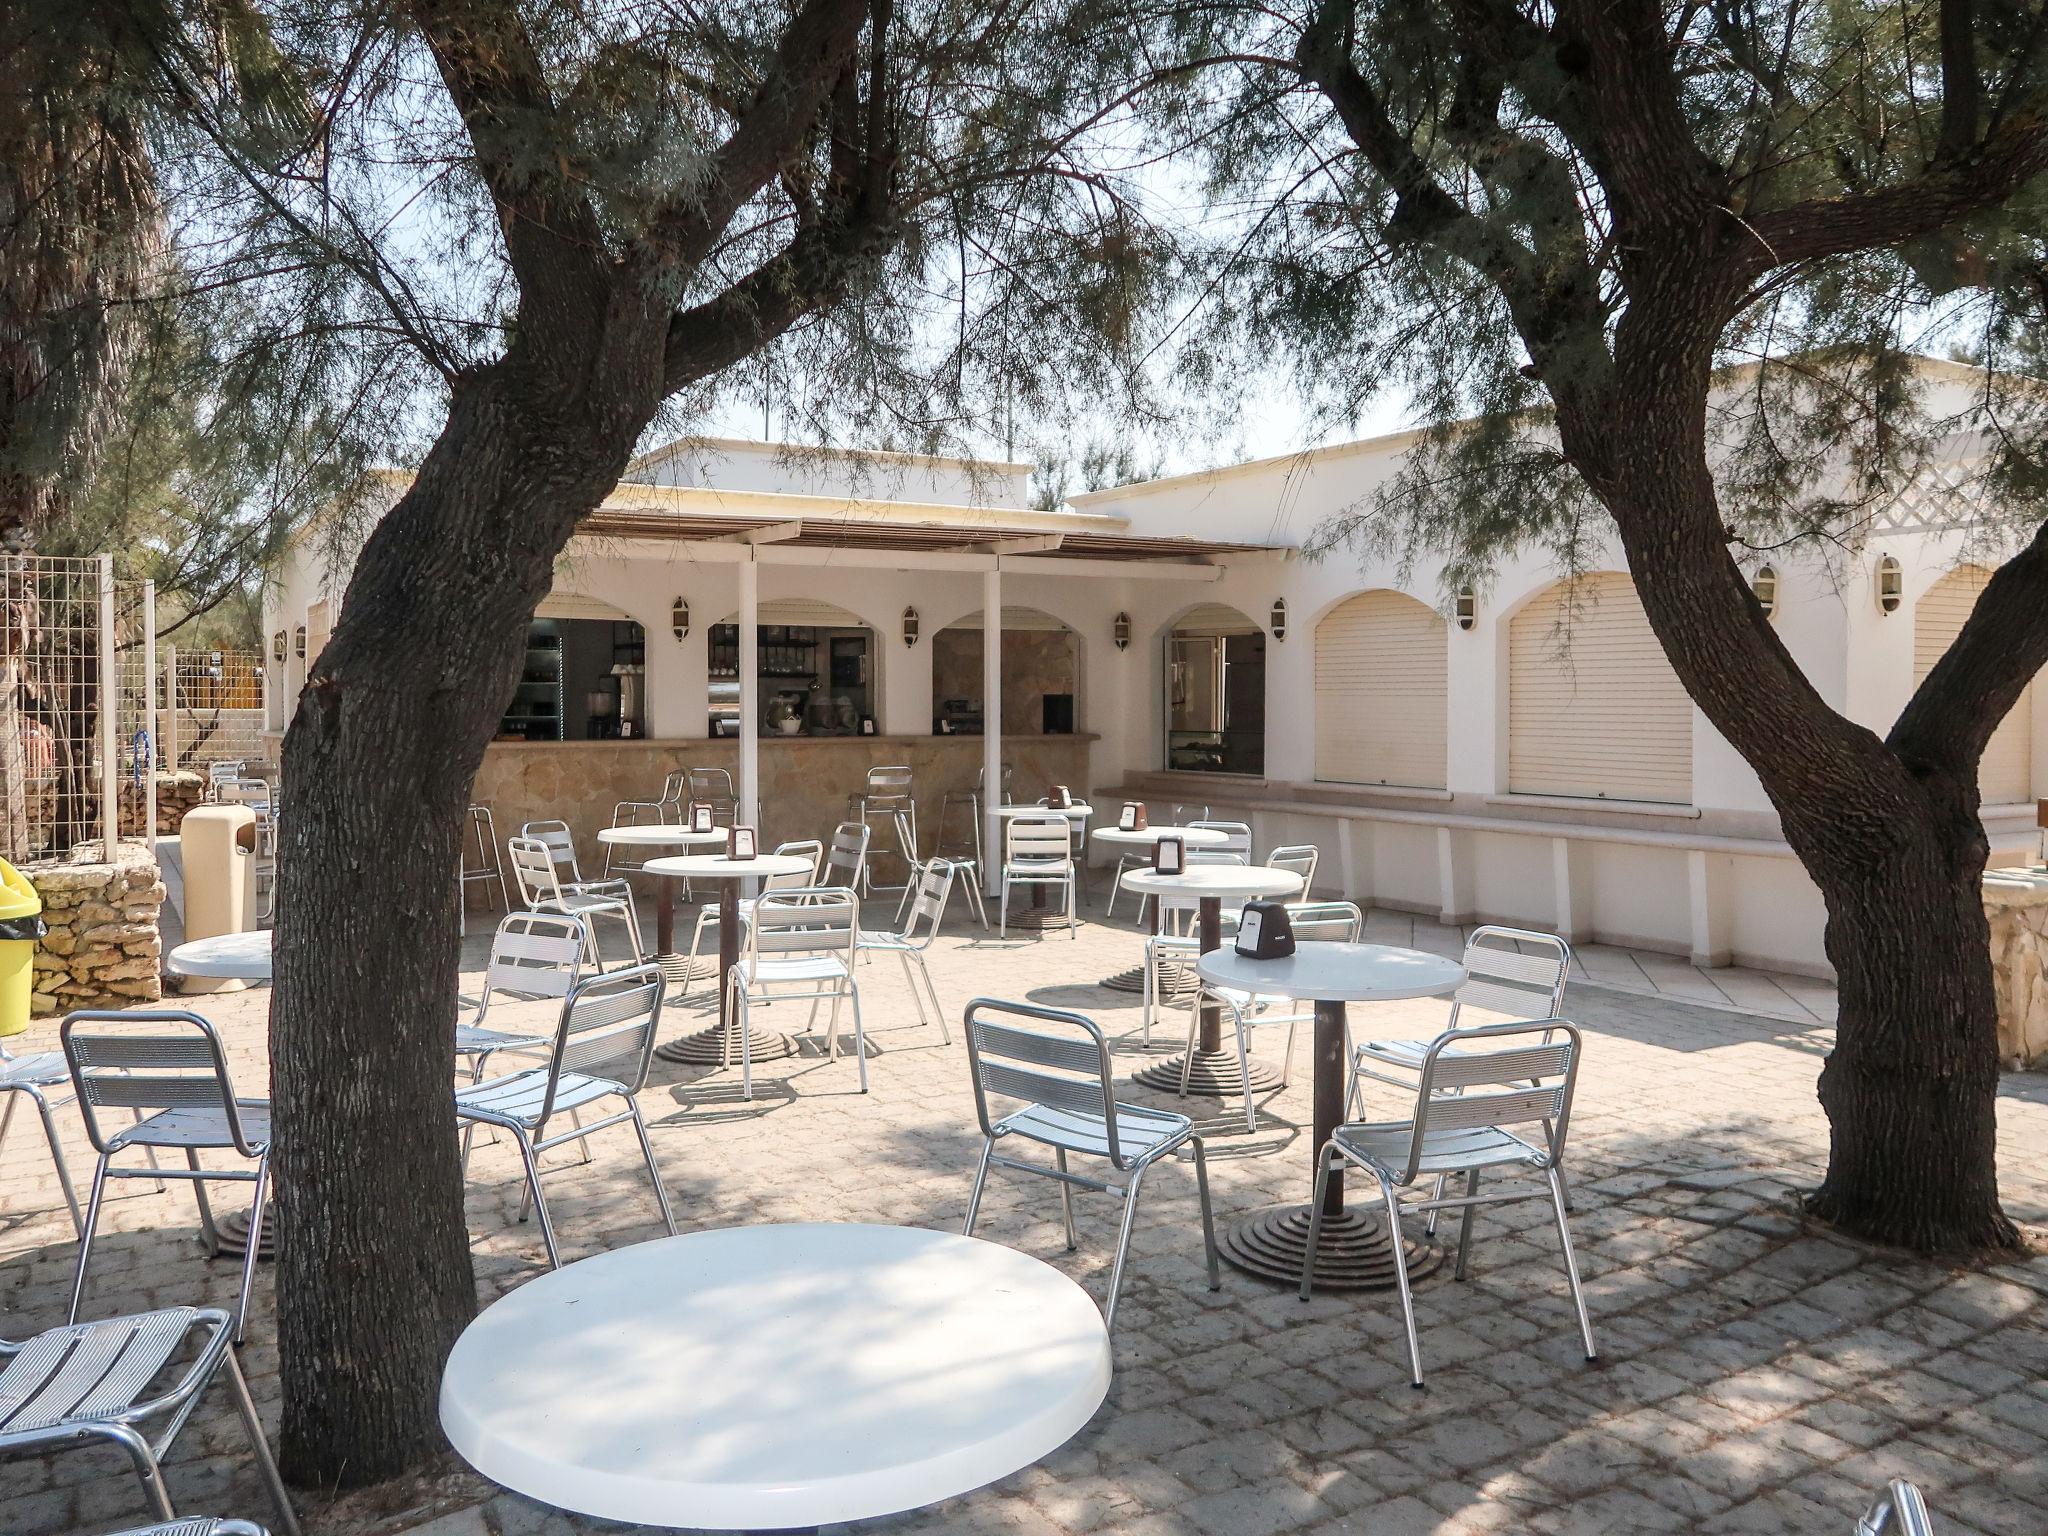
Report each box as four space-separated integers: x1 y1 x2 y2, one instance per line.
57 1024 270 1343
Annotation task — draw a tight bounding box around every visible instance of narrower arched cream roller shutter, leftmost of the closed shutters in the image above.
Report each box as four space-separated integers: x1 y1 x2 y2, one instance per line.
1315 592 1450 788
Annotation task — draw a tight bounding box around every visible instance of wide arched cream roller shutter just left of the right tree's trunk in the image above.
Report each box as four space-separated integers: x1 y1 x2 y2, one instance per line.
1507 571 1692 805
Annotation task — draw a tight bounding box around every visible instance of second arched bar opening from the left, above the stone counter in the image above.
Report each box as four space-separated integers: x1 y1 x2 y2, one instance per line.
707 598 881 735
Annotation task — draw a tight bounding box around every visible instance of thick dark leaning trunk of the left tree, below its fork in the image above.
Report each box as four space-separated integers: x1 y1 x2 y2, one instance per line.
270 360 653 1487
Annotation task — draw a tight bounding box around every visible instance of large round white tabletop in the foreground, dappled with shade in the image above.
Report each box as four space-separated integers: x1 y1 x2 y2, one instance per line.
440 1223 1110 1530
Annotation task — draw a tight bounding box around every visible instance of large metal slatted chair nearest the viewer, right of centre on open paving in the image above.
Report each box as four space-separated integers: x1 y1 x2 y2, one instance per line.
1300 1018 1599 1389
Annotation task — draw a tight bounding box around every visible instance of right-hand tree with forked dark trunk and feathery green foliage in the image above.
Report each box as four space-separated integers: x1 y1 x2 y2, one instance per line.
1155 0 2048 1249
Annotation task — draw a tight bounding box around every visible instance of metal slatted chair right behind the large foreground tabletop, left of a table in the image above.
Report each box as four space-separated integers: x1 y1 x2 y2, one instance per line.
961 997 1223 1331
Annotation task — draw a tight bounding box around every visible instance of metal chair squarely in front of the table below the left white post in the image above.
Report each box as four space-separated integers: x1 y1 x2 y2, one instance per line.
723 885 868 1100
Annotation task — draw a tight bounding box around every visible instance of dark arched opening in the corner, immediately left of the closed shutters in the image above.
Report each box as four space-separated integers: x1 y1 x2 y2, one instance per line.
1165 602 1266 776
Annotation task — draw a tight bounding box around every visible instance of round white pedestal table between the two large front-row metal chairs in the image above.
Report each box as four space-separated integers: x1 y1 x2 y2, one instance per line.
1196 942 1464 1290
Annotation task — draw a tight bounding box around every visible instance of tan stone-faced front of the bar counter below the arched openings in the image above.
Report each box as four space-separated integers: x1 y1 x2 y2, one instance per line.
473 735 1094 877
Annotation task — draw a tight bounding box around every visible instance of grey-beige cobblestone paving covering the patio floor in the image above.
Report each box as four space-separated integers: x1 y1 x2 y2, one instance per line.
0 909 2048 1536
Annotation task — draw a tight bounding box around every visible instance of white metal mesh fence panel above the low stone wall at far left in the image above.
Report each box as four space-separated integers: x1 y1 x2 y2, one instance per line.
0 555 154 860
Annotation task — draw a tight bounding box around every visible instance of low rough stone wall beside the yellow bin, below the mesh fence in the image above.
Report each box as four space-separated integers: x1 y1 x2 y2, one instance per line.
23 842 164 1014
